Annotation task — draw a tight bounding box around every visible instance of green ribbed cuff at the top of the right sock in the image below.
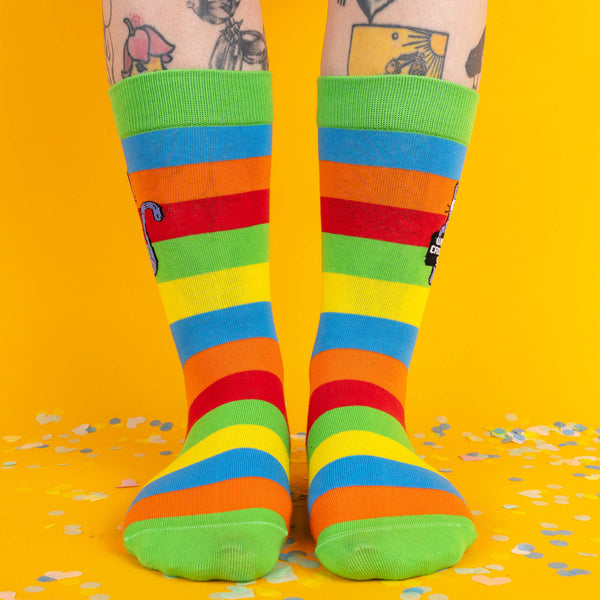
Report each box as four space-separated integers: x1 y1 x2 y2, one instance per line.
317 75 479 145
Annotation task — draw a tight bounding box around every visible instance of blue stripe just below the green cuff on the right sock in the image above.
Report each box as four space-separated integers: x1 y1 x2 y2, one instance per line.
319 127 467 180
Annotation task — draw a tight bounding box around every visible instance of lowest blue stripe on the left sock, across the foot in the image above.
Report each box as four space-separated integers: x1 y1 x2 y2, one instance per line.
129 448 290 509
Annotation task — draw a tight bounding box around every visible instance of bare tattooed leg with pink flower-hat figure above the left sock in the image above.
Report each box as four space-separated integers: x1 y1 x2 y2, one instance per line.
103 0 268 85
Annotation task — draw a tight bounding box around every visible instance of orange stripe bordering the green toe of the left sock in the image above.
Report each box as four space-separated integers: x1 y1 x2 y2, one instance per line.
124 477 292 530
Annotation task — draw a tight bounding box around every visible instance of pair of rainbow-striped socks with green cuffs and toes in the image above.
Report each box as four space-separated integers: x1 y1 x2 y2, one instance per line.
109 70 478 581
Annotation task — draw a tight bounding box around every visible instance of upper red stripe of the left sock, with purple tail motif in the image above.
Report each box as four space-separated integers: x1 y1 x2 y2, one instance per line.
141 190 269 242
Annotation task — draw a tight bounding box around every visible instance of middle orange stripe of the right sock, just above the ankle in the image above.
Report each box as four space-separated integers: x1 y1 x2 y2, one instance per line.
310 348 408 402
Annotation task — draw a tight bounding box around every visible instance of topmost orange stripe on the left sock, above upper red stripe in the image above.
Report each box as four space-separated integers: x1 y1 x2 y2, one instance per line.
129 156 271 208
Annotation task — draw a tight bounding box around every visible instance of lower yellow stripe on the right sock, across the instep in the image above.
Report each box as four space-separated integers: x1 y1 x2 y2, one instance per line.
309 430 439 483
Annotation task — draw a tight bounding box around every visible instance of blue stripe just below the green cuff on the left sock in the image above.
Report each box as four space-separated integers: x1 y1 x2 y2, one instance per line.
122 125 271 173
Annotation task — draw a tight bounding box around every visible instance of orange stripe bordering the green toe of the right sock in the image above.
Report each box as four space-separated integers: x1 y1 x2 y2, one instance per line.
310 485 472 540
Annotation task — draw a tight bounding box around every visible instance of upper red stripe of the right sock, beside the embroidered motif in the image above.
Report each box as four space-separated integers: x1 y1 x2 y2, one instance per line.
321 197 447 247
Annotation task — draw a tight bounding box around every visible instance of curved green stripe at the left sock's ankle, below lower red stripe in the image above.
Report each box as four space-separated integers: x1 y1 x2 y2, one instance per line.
180 400 290 454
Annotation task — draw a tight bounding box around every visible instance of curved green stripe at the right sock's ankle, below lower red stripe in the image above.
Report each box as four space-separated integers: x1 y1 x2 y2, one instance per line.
306 406 416 460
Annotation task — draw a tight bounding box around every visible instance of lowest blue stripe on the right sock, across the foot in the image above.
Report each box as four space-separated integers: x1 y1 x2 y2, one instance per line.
308 454 464 513
